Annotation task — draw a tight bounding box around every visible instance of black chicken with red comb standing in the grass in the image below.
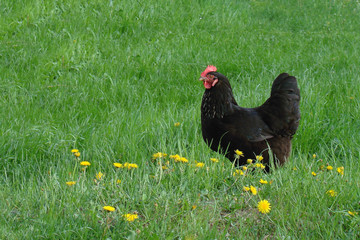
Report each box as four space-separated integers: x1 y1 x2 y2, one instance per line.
199 66 300 171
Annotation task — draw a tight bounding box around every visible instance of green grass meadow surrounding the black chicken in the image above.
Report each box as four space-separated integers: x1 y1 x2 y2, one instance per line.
0 0 360 240
